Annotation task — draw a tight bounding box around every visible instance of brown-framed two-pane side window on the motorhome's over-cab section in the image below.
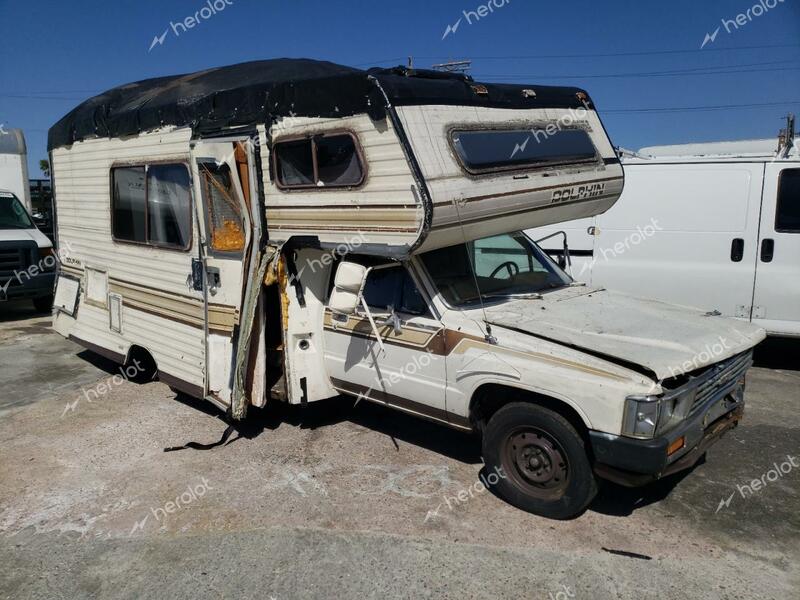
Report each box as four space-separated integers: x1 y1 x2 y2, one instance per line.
273 134 364 188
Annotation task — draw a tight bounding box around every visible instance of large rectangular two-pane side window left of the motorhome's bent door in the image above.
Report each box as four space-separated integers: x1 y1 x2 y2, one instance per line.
111 163 192 250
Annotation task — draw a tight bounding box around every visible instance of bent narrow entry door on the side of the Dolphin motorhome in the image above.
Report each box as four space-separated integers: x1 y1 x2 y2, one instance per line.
192 138 256 404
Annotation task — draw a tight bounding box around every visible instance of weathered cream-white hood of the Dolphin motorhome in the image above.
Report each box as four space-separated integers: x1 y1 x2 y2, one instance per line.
486 286 766 380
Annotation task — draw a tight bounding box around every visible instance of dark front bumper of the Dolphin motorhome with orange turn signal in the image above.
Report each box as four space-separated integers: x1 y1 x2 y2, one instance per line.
589 370 744 487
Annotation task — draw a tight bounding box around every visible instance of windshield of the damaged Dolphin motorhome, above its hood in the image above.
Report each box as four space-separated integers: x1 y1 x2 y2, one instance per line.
421 232 571 307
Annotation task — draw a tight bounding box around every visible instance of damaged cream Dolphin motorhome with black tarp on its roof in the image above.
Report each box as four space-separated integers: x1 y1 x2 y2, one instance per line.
49 59 764 518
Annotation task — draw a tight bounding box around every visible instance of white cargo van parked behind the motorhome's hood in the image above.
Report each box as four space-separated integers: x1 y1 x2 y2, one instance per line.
529 127 800 337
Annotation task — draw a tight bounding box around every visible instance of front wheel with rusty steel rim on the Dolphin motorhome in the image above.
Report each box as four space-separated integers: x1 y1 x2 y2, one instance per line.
483 402 597 519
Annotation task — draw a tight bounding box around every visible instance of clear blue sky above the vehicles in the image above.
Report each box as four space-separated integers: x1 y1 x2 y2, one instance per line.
0 0 800 177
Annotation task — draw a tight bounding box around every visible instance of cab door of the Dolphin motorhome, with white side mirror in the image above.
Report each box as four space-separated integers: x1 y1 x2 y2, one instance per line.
325 258 447 422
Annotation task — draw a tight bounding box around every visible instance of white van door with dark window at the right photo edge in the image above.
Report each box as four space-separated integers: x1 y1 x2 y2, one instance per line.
753 162 800 335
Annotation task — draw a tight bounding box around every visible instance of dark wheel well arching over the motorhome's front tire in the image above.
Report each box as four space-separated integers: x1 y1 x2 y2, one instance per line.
469 383 590 448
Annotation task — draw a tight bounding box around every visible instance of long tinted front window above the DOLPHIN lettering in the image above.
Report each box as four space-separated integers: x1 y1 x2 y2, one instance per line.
451 129 596 172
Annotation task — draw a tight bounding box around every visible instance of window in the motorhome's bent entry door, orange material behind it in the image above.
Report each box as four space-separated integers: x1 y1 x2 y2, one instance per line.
199 163 245 252
